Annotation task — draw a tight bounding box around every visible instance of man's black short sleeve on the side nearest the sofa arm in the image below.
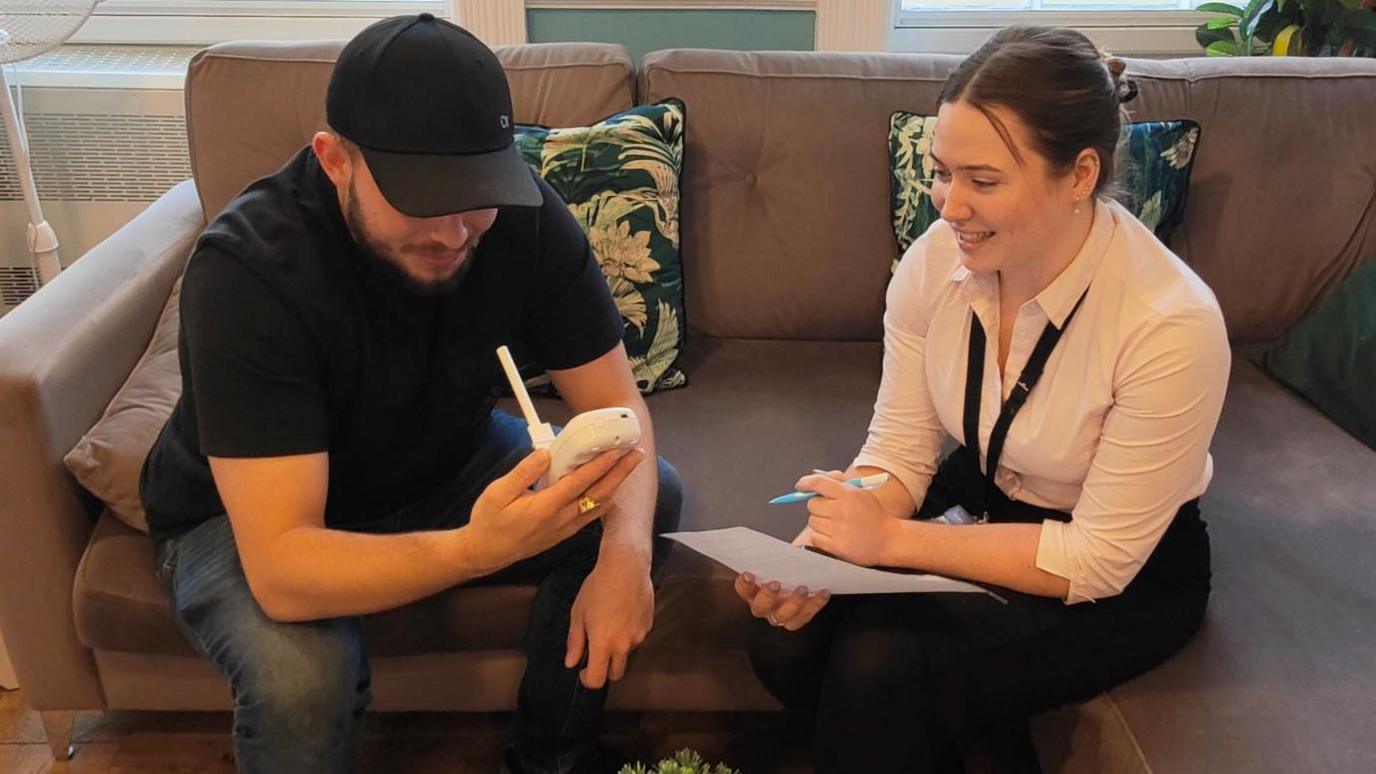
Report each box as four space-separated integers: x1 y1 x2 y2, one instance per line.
182 244 330 457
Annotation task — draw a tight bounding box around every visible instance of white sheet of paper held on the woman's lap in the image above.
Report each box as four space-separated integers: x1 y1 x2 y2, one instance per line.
665 526 999 599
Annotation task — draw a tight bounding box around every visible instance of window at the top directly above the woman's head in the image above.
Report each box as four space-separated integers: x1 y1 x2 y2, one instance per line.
889 0 1210 56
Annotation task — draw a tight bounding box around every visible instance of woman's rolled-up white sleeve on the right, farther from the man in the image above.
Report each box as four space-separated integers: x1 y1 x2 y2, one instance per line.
1036 307 1232 605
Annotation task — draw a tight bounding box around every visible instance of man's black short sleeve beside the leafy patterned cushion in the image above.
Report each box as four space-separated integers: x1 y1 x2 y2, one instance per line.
522 180 625 370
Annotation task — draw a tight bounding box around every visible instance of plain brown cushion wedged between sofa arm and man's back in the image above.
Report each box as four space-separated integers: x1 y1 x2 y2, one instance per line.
62 278 182 533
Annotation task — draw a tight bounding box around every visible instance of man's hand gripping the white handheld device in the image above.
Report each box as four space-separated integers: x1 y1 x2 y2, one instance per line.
465 449 645 573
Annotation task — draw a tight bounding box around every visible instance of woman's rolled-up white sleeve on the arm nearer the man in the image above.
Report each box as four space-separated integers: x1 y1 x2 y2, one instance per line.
853 237 944 505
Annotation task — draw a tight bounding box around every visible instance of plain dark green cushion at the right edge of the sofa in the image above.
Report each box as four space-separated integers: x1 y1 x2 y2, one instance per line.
1260 264 1376 449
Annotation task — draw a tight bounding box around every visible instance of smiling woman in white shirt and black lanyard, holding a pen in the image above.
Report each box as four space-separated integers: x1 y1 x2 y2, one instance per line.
736 28 1230 773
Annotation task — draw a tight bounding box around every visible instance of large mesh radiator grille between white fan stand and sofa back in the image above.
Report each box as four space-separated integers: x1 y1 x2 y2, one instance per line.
0 113 191 201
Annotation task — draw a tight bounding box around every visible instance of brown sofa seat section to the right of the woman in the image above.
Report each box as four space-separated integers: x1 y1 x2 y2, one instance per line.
1084 357 1376 773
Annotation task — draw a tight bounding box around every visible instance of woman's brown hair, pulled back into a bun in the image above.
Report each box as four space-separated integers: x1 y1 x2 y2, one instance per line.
937 25 1137 194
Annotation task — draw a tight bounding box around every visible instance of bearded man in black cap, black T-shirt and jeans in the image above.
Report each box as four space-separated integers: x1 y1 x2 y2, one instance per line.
142 14 681 774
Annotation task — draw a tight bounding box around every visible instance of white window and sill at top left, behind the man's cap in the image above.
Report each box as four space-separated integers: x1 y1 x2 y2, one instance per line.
73 0 449 45
